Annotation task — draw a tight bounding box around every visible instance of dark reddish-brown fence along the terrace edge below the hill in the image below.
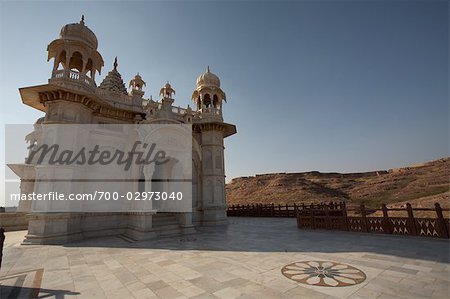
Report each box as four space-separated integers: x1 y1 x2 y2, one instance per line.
227 202 450 238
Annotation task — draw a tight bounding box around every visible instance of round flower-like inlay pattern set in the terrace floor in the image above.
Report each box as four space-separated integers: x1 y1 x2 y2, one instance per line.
281 261 366 287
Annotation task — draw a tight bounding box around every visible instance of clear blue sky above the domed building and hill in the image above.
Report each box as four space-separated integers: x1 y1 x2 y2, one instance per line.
0 0 449 192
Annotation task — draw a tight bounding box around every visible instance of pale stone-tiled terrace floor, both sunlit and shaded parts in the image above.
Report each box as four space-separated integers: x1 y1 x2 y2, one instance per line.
0 217 450 298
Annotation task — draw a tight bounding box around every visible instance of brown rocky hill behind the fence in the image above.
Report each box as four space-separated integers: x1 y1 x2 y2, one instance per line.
226 157 450 208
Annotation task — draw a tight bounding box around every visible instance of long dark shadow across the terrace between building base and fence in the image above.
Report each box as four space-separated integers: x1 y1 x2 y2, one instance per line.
51 217 450 263
